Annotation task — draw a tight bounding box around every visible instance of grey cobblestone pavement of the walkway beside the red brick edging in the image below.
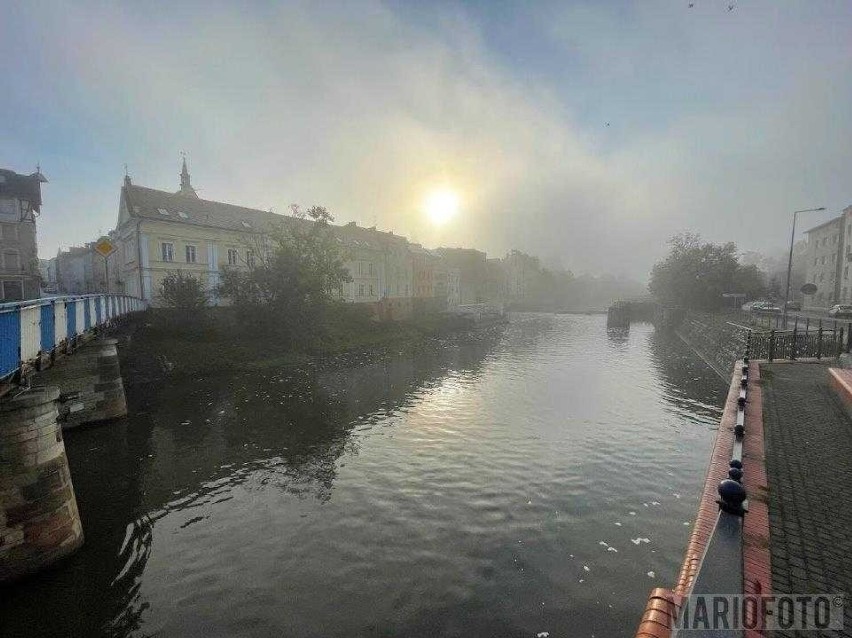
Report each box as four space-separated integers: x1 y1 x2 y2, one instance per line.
760 363 852 638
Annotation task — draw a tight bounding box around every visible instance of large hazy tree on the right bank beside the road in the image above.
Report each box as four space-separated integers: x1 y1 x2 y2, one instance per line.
648 233 766 310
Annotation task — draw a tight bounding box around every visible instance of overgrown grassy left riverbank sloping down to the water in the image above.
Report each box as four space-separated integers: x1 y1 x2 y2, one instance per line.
113 308 490 384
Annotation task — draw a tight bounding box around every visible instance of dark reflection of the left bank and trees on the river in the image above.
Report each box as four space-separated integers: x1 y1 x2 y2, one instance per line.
0 330 502 637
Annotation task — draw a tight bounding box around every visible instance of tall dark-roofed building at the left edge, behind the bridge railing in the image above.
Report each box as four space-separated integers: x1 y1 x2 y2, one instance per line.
0 169 47 301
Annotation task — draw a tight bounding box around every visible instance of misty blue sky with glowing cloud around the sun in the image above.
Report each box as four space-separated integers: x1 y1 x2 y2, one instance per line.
0 0 852 279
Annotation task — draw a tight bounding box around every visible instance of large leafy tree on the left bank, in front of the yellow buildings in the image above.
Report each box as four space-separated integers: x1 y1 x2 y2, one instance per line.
219 204 351 341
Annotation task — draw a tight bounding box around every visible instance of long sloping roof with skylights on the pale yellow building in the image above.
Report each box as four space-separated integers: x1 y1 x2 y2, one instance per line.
121 184 296 232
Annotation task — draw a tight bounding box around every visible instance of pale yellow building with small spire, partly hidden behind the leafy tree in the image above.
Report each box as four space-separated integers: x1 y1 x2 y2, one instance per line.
110 160 414 306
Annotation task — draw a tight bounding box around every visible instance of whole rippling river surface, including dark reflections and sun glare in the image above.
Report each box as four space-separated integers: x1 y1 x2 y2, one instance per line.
0 314 726 638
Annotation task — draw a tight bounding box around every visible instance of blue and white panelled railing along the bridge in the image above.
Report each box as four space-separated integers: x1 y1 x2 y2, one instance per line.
0 294 147 380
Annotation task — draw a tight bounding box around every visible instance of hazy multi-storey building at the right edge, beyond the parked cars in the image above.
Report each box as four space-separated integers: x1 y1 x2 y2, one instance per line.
805 206 852 307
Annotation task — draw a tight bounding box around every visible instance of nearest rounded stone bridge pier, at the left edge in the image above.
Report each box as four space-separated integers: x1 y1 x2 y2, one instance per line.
0 387 83 582
